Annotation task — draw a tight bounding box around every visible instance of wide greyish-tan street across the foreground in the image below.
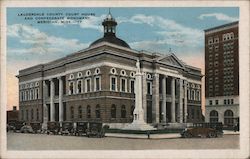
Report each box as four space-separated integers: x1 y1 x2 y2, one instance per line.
7 133 239 150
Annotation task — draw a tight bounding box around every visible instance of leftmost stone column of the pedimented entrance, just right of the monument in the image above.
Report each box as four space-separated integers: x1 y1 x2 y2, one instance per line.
152 73 159 123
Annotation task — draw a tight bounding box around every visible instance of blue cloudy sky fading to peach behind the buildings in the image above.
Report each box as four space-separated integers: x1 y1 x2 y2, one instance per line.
7 7 239 110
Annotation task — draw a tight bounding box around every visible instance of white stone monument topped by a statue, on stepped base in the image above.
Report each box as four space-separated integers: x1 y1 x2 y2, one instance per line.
123 59 155 130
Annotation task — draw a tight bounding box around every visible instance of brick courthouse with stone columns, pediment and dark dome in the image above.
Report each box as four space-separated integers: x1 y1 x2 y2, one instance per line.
17 13 202 124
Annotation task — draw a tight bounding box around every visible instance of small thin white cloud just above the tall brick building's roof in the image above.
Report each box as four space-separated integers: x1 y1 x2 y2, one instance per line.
198 13 238 22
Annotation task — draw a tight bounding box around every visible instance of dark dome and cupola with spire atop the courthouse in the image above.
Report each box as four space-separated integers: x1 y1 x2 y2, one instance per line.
90 10 130 48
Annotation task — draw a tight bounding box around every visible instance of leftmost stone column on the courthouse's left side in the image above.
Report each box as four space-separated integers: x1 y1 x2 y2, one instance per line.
42 80 48 130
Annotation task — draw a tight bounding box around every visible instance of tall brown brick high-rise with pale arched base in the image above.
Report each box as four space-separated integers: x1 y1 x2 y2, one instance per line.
205 22 239 126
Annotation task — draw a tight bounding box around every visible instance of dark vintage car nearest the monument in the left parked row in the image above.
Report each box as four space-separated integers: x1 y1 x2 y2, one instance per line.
86 122 109 138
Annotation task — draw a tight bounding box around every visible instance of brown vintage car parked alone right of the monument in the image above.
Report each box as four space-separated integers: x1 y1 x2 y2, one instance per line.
181 123 223 138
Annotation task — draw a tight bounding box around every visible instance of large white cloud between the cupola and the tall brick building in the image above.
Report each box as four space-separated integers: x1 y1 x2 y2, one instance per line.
120 14 204 49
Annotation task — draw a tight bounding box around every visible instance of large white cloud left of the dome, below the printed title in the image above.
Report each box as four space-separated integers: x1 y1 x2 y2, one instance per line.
7 24 88 55
